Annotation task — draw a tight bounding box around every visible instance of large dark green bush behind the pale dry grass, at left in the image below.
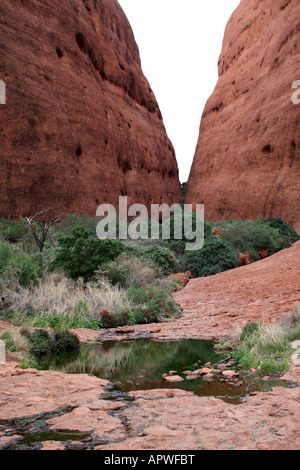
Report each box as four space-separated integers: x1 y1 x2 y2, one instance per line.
55 227 125 280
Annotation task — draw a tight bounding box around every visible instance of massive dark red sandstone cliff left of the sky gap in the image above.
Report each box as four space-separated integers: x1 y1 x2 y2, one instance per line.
0 0 181 217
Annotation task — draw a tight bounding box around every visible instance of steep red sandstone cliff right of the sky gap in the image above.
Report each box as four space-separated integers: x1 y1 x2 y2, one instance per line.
186 0 300 231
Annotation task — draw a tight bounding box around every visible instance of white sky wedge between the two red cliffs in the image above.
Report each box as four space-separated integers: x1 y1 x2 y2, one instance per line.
119 0 240 182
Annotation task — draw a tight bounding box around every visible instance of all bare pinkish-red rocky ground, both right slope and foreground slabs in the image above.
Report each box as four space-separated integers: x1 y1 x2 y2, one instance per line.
0 243 300 450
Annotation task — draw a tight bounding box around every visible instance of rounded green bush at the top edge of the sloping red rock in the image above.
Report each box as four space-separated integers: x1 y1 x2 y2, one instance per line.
184 239 239 277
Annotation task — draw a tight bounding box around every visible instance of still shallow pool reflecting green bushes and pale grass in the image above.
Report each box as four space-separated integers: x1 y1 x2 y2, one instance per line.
40 339 251 397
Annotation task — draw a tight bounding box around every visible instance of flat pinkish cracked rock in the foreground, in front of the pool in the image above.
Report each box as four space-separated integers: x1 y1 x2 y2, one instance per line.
0 366 300 450
